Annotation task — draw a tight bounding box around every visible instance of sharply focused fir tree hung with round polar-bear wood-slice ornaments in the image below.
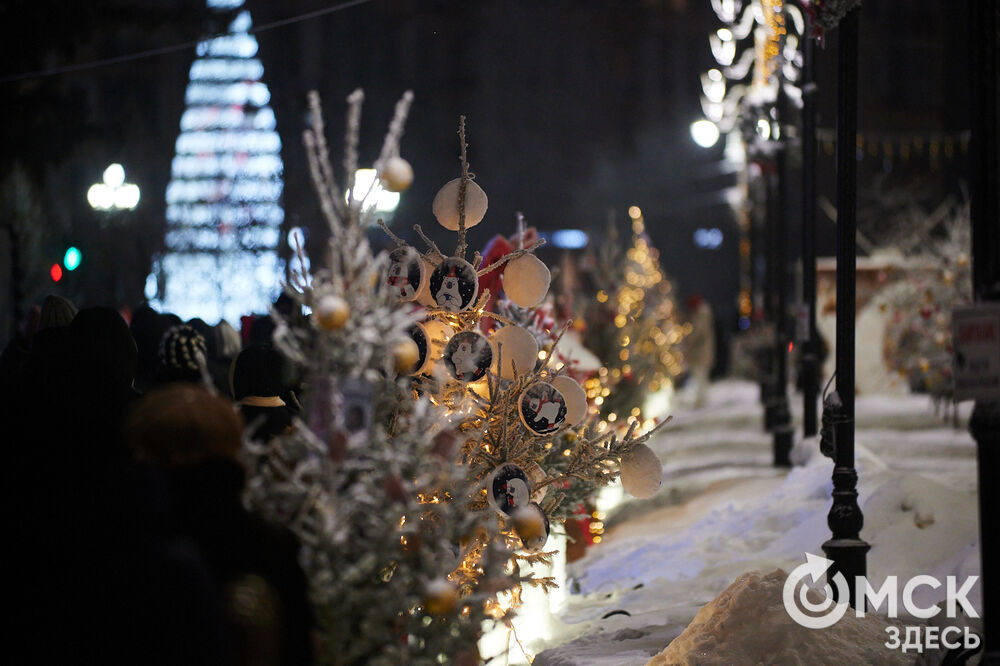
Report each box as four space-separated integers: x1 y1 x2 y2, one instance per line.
382 118 661 609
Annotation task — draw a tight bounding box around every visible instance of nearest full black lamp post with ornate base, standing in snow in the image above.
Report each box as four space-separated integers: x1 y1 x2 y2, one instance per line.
823 8 870 608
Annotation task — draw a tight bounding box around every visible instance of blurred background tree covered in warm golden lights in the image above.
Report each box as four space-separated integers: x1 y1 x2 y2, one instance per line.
583 207 690 423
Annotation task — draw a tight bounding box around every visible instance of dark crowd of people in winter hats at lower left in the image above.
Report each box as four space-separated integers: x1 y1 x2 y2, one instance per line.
0 295 314 666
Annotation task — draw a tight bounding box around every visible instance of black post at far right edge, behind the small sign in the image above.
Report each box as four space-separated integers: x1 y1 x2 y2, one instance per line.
969 0 1000 664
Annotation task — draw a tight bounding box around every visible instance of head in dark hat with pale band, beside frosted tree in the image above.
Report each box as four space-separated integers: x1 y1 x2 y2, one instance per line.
229 345 292 441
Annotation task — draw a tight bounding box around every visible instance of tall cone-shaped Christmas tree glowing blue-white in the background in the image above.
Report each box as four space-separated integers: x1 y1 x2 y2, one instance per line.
152 0 284 324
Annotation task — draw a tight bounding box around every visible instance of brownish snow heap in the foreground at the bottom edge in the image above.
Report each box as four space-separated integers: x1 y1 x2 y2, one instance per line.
647 569 913 666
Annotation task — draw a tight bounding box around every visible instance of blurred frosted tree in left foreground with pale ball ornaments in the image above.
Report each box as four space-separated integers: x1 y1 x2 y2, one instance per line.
247 91 521 664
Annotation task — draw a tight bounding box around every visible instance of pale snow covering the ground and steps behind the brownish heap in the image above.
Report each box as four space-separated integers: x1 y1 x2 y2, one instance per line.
532 381 980 666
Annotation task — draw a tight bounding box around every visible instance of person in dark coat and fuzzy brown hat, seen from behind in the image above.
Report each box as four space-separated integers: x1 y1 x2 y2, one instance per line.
125 384 312 666
